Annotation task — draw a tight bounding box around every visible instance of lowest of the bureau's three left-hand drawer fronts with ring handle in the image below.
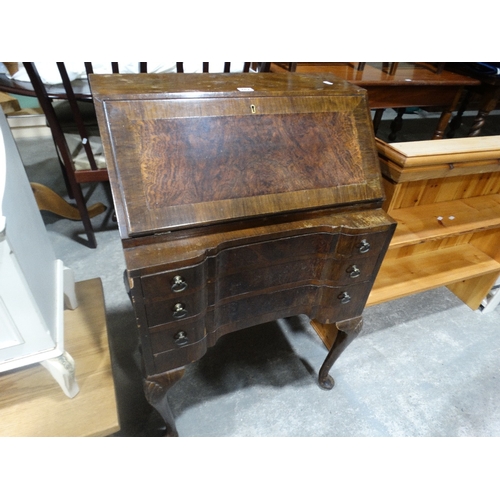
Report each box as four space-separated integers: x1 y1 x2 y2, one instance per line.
149 315 205 354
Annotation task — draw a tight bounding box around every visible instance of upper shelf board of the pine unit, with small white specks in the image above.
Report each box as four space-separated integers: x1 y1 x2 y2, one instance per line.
390 194 500 248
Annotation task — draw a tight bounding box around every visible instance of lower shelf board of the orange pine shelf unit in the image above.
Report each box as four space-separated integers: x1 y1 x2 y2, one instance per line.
367 245 500 306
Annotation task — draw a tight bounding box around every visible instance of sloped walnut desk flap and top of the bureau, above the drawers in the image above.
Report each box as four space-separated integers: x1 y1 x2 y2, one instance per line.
91 73 382 238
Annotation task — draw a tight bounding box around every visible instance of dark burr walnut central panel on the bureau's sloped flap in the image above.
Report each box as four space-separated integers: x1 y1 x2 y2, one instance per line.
138 113 364 209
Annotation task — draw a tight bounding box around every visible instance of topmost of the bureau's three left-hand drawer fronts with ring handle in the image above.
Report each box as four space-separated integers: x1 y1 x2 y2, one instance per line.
141 264 205 299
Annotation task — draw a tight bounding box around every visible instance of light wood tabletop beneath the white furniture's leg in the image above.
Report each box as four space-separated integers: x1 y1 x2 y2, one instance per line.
0 278 120 437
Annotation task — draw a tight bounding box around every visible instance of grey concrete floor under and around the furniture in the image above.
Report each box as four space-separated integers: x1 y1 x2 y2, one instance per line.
13 110 500 437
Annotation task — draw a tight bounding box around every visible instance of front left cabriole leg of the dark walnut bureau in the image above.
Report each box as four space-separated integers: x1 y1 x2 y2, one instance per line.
144 368 184 437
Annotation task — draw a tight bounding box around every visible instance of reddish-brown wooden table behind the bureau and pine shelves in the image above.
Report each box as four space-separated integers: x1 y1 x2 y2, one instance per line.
269 62 480 139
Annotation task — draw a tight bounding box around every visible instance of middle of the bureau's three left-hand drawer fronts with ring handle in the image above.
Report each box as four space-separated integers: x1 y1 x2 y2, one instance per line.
144 289 206 327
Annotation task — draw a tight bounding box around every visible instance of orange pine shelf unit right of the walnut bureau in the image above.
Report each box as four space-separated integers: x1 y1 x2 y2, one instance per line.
367 136 500 309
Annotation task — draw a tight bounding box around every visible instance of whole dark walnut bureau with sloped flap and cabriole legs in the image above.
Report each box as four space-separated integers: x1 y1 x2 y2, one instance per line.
91 73 395 435
